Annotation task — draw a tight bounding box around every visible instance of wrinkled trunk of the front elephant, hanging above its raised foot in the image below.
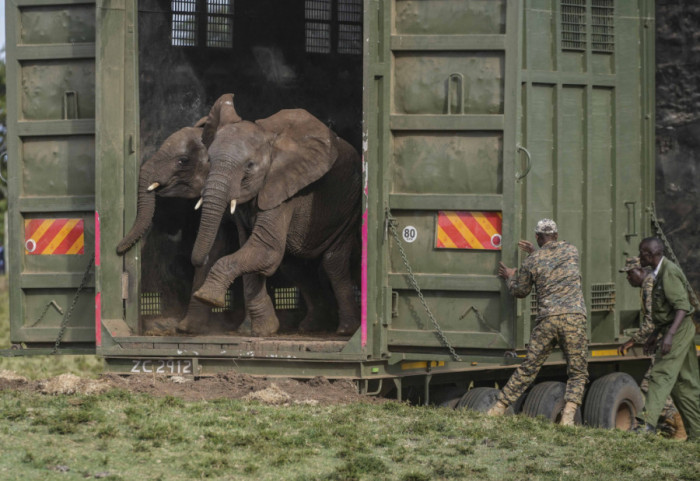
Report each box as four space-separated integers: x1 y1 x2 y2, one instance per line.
192 162 240 266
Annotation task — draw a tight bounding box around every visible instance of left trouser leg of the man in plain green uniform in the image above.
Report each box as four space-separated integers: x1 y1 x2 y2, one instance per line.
644 318 697 426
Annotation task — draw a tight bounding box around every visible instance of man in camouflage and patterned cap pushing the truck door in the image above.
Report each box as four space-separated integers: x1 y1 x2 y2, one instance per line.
487 219 588 426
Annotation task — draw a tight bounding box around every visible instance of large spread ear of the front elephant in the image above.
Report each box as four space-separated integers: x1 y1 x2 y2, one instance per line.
256 109 338 210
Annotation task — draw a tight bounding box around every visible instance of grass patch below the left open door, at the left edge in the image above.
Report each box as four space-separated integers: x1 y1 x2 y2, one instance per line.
0 276 102 378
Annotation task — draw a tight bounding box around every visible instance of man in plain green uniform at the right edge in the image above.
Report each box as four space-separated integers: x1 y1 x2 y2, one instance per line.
639 237 700 441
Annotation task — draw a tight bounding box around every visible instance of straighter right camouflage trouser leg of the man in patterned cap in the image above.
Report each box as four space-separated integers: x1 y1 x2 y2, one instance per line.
557 314 588 405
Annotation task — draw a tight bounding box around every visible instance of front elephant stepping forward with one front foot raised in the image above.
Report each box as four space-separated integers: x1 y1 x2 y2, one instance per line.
192 106 361 336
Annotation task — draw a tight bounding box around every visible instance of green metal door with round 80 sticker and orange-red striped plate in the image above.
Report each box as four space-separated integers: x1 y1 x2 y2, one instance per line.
378 0 520 351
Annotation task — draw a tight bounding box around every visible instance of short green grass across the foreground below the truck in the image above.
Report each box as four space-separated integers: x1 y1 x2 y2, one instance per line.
0 391 700 481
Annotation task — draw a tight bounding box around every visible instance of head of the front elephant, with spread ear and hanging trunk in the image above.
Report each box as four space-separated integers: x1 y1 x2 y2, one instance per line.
192 109 338 266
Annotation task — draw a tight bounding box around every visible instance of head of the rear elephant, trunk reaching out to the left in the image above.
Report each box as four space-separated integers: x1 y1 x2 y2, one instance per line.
117 126 209 255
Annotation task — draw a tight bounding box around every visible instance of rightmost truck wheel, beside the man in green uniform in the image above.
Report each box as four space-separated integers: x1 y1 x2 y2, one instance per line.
583 372 644 431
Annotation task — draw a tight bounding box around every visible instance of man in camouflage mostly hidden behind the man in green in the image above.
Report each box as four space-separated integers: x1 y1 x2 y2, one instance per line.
617 257 686 438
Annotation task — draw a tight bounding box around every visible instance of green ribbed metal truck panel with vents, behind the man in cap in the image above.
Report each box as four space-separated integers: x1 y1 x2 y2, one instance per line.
520 0 654 343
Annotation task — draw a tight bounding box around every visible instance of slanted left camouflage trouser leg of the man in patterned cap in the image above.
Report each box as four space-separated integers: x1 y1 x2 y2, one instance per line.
498 317 556 406
